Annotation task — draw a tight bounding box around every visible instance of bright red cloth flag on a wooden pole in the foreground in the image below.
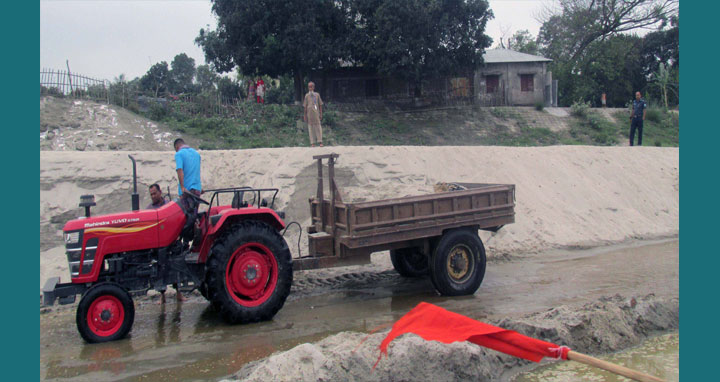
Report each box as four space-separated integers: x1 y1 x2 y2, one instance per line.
375 302 570 365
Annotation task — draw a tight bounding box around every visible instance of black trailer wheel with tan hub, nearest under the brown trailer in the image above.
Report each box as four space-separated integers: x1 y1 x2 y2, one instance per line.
430 229 486 296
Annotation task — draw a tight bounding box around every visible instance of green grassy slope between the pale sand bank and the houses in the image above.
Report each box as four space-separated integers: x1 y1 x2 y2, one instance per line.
129 98 679 150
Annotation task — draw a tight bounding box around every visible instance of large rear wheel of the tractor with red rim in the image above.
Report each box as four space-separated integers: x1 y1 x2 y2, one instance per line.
206 220 293 324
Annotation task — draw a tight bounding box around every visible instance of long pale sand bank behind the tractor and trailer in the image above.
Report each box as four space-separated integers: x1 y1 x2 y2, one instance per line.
40 142 679 285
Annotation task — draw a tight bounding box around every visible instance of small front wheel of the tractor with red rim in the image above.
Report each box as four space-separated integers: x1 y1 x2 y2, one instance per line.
75 283 135 343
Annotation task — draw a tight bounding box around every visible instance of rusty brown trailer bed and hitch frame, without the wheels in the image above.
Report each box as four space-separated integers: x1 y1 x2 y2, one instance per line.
293 154 515 270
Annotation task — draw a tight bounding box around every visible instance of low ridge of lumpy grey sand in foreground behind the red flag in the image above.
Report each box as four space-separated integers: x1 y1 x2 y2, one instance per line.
224 295 679 382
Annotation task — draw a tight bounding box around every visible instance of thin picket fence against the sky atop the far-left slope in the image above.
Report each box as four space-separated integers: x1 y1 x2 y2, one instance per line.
40 69 110 103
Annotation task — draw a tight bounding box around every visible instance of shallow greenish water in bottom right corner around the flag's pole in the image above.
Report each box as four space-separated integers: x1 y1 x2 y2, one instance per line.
511 332 680 382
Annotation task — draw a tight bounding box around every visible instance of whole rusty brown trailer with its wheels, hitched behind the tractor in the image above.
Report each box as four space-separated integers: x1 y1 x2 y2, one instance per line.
293 153 515 296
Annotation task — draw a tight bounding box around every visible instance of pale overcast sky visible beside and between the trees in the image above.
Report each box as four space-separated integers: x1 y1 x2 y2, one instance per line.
40 0 549 80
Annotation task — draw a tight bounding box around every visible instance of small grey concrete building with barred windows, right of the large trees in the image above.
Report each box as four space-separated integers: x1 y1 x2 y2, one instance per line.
474 49 557 106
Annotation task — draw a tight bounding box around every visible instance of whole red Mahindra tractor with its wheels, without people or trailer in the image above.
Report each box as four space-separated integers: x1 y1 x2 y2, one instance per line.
43 157 293 343
